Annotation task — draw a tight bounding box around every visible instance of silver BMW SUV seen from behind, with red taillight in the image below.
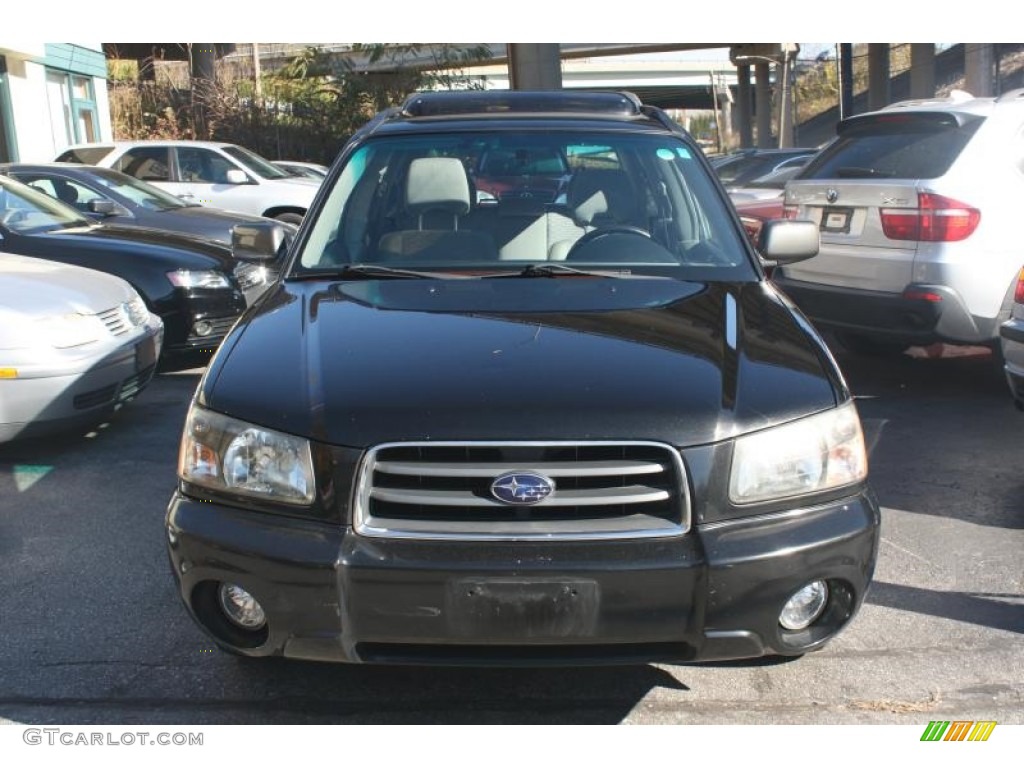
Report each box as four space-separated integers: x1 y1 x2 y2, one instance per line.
775 90 1024 353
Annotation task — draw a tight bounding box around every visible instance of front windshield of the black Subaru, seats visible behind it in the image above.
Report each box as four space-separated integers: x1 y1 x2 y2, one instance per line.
292 131 756 280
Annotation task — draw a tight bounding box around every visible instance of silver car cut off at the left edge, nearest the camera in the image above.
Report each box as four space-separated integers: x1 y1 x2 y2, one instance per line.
0 253 163 442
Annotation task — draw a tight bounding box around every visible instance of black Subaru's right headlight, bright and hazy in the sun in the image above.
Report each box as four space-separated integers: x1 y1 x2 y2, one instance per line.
729 401 867 504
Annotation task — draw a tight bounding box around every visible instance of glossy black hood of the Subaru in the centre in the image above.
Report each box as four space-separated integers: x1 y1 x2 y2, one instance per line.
199 279 849 447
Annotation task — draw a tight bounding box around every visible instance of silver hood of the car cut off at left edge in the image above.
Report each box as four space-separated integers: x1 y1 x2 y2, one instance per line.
0 253 136 349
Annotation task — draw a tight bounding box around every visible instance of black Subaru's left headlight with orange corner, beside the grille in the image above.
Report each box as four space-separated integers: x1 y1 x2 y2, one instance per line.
178 406 314 504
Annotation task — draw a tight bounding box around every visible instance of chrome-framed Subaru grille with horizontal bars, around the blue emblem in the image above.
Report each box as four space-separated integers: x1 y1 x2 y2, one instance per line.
353 442 690 541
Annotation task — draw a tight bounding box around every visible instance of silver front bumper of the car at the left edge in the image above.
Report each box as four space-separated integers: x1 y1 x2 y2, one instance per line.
0 314 164 442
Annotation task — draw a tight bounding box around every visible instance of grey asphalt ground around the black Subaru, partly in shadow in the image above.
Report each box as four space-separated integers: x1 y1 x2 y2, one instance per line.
0 339 1024 725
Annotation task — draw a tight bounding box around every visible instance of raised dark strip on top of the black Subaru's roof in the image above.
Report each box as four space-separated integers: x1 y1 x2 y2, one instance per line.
401 90 642 118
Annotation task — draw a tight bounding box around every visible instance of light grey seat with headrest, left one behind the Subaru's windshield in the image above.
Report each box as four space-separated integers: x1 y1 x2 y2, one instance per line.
377 158 498 263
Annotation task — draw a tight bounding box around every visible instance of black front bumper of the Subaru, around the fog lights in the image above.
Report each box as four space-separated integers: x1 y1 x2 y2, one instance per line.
167 490 879 666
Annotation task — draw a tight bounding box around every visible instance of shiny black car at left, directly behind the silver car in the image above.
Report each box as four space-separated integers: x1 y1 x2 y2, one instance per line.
0 176 247 355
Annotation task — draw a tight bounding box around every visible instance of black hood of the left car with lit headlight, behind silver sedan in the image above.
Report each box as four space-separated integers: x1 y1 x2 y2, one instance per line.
20 224 234 272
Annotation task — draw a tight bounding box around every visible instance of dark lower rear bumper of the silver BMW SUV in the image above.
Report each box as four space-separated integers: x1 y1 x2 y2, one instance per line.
772 270 998 346
